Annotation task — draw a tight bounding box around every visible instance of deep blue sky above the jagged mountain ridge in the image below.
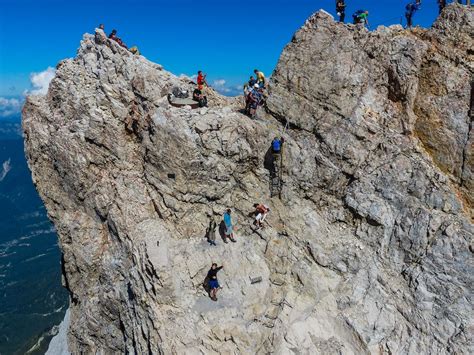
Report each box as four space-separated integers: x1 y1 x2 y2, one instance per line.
0 0 444 114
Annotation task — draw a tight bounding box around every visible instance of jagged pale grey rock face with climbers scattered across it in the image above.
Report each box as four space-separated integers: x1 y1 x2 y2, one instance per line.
23 6 474 354
